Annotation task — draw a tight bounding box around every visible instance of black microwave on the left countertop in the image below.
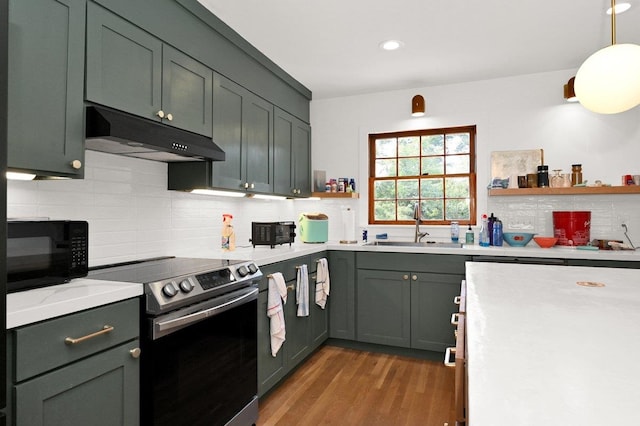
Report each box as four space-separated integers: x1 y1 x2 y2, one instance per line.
7 220 89 293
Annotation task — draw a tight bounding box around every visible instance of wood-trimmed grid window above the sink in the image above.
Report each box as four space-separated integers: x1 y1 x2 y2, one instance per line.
369 126 476 225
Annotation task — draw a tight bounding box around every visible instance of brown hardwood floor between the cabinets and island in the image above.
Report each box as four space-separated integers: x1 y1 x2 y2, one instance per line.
257 346 455 426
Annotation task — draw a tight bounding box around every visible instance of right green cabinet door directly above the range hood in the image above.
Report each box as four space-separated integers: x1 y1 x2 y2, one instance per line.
162 45 213 136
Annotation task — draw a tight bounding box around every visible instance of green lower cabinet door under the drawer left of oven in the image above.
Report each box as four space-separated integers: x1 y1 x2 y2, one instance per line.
15 340 139 426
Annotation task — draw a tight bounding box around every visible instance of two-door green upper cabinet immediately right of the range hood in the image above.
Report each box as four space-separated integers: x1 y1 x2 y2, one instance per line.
212 73 273 193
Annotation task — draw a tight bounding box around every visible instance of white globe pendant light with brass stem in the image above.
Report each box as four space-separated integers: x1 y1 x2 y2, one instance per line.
575 0 640 114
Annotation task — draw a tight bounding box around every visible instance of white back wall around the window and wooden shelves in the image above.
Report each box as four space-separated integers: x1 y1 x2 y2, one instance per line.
311 70 640 243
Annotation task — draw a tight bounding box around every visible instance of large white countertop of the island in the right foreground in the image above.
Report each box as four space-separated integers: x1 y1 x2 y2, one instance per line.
466 262 640 426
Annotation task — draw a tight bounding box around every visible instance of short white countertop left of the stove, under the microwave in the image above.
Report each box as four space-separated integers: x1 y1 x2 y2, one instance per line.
7 278 143 330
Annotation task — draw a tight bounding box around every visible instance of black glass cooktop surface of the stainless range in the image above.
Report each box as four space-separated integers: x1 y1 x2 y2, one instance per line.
87 257 242 284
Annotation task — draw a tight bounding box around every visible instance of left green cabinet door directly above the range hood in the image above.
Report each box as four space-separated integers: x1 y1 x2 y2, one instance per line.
86 2 162 120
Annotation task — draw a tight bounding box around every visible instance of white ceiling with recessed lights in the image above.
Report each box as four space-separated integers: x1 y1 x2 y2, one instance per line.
199 0 640 99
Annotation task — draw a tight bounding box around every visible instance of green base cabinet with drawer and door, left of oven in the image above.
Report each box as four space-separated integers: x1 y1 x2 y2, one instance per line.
8 299 141 426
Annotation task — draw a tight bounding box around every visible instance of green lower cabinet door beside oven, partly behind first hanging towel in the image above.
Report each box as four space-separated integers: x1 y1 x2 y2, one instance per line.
258 290 286 397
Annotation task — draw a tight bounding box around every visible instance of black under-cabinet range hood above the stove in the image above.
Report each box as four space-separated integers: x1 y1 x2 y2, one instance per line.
86 105 225 163
